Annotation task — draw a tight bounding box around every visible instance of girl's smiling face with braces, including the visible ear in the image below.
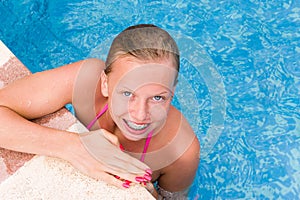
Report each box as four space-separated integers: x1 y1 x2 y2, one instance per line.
101 57 177 141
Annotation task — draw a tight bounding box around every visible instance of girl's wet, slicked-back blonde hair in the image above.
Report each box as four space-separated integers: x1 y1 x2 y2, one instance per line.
105 24 180 74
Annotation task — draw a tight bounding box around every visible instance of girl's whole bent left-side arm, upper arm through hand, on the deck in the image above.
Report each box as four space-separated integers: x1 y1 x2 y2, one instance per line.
0 61 147 186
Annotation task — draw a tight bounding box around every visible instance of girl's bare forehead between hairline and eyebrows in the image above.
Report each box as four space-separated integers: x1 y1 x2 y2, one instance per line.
110 58 177 90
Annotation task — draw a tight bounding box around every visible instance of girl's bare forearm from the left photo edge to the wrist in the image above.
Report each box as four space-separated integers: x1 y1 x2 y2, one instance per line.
0 106 76 158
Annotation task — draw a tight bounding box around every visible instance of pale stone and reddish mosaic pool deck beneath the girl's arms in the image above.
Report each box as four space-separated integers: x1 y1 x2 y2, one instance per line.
0 40 154 199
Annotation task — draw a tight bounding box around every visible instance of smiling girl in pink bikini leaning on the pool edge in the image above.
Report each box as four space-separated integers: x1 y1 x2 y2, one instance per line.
0 24 200 199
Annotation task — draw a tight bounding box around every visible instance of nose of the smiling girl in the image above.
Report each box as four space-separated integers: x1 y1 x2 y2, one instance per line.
129 99 149 122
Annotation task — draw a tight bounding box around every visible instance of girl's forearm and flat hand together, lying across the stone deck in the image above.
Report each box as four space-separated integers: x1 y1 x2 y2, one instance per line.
0 106 149 186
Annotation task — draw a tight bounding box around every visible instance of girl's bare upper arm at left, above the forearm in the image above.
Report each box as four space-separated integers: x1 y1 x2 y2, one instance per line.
0 59 103 119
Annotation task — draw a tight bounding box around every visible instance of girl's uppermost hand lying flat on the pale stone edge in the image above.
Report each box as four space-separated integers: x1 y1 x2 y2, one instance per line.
64 129 150 187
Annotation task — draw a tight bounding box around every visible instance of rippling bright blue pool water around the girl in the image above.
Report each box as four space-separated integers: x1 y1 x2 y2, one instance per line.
0 0 300 200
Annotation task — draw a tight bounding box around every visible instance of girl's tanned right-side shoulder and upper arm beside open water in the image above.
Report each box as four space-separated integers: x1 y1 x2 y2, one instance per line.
159 107 200 192
